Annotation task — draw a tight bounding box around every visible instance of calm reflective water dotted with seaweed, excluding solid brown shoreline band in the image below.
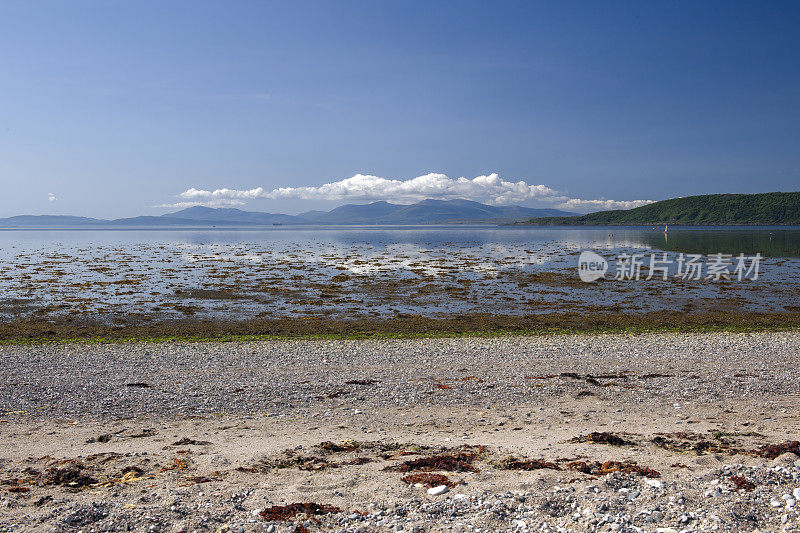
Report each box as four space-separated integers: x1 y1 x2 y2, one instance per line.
0 226 800 319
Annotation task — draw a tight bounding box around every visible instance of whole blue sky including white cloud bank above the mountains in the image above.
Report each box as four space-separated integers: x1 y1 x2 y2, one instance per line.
0 0 800 217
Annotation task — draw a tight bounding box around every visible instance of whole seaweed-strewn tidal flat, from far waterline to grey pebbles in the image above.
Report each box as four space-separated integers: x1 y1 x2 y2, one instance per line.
0 227 800 339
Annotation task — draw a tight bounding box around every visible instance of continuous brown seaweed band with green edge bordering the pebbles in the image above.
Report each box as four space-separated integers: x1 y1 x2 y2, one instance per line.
0 308 800 343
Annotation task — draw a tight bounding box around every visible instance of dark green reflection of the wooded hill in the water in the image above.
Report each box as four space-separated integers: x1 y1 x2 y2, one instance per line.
642 228 800 257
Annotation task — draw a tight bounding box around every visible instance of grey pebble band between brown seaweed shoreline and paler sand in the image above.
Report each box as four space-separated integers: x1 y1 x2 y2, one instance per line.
0 332 800 419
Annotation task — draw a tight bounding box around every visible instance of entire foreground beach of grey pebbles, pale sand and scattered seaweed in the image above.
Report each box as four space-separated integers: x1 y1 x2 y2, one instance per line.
0 332 800 532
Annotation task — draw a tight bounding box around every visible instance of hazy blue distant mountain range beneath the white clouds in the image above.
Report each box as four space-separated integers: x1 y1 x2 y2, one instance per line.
0 200 574 228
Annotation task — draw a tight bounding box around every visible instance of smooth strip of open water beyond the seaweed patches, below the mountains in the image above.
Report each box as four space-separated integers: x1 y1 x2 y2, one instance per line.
0 225 800 257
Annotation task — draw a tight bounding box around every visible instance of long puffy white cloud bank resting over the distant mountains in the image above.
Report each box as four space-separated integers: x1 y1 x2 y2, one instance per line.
160 173 652 211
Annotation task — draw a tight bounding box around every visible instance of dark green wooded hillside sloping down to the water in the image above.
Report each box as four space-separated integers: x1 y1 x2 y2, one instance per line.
515 192 800 226
